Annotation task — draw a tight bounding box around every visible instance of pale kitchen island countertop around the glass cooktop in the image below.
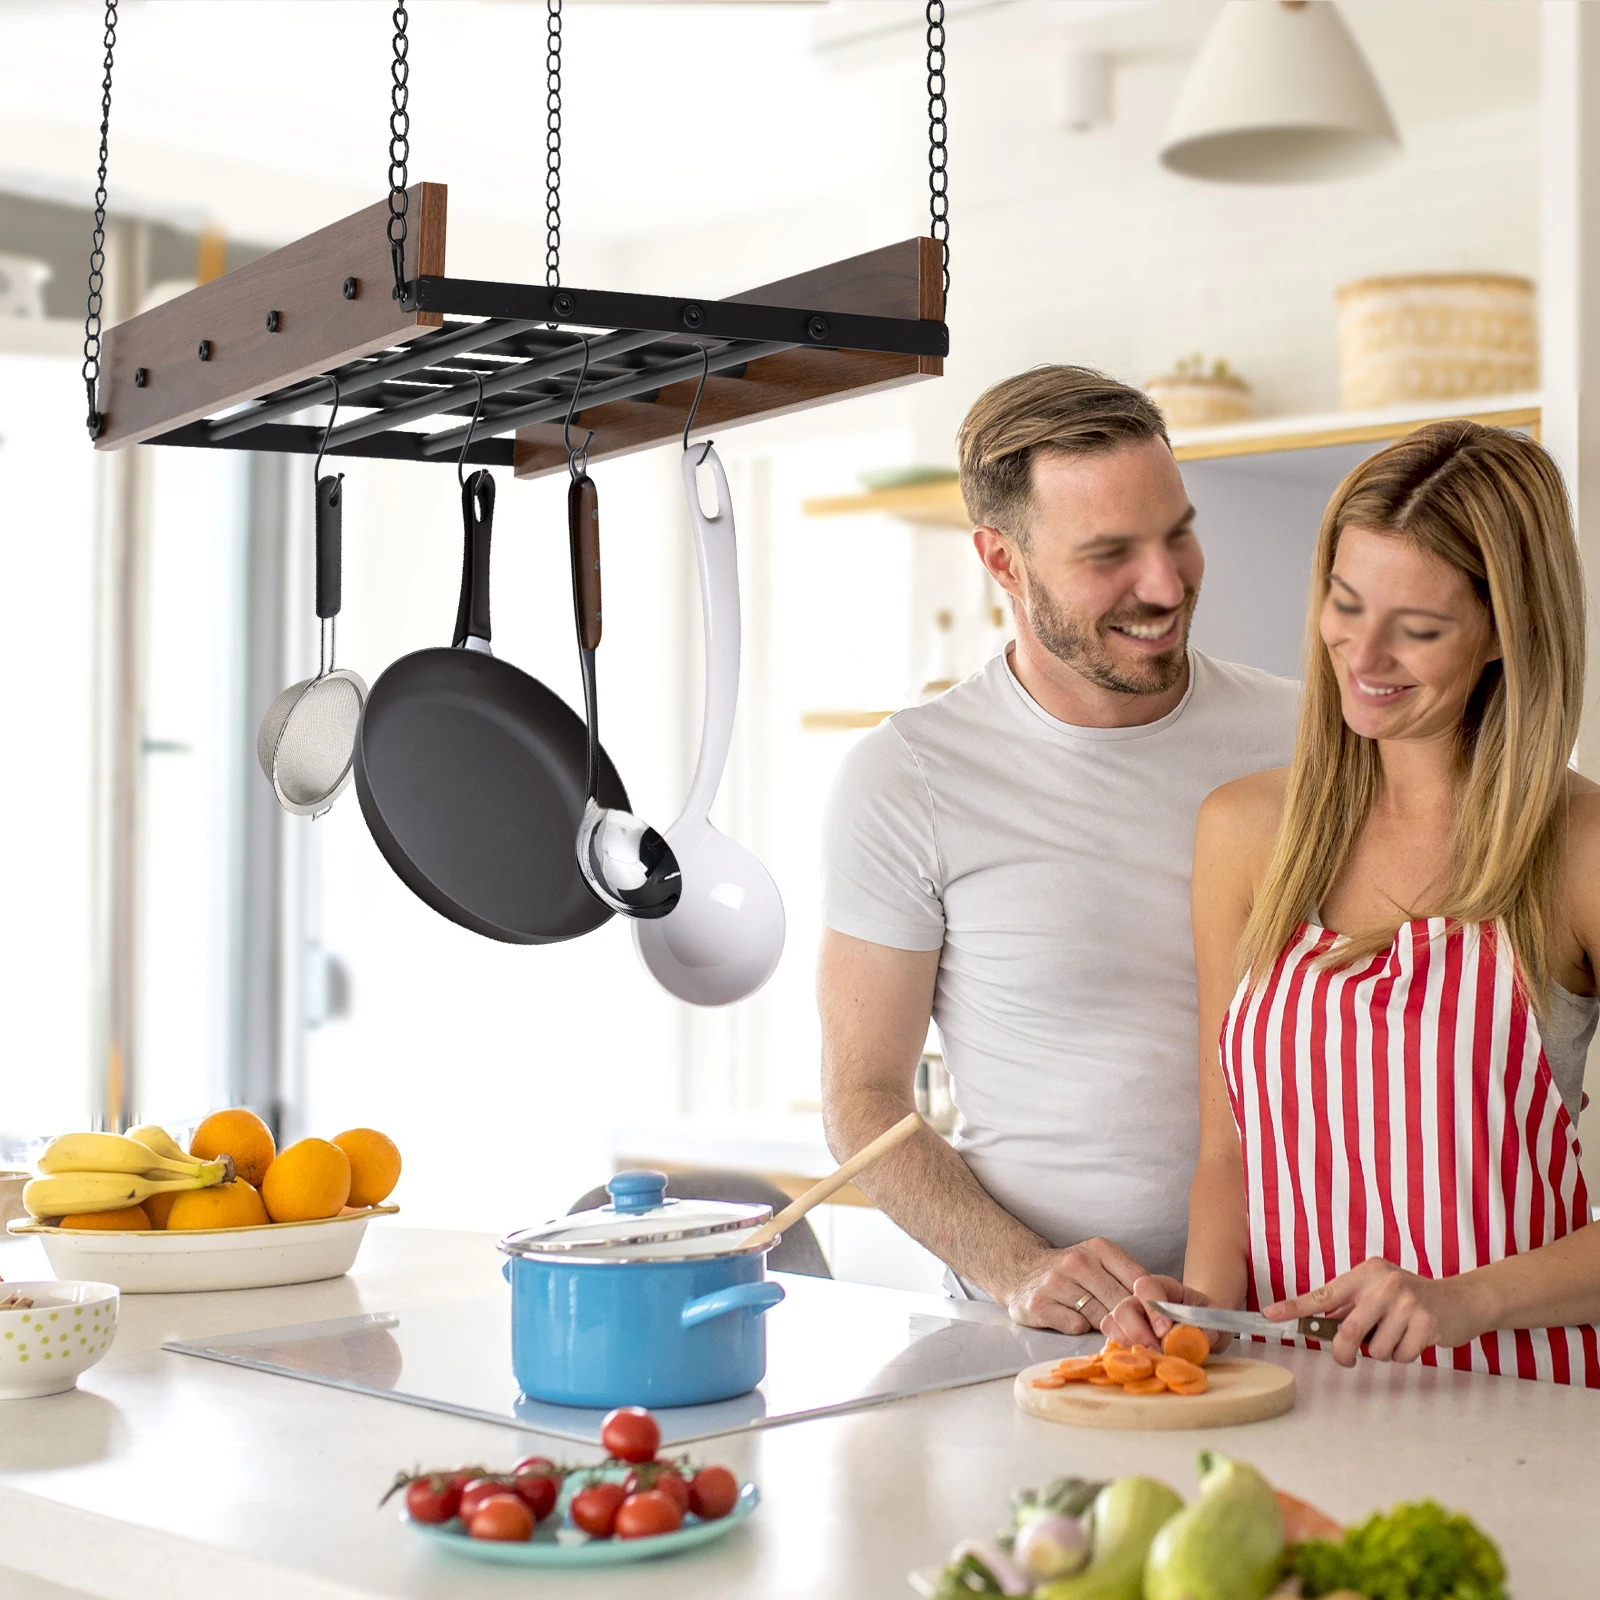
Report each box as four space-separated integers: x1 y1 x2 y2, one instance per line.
0 1224 1600 1600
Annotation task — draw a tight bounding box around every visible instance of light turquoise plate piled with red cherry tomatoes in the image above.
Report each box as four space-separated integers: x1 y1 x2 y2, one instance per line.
384 1406 760 1566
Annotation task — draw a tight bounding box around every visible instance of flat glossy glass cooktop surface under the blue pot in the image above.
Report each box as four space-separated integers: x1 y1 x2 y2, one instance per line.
162 1274 1101 1446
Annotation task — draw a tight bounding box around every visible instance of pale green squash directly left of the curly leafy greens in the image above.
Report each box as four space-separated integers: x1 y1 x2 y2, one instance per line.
1144 1450 1283 1600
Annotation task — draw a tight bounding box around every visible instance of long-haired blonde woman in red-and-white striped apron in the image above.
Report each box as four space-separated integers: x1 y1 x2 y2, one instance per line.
1102 422 1600 1387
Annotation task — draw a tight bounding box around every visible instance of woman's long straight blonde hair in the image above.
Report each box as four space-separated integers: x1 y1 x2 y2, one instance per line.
1238 422 1584 1011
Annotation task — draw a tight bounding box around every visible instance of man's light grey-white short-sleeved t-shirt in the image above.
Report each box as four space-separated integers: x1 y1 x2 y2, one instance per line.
822 651 1299 1275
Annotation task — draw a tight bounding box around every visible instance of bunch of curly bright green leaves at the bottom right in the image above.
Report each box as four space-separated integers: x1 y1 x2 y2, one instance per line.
1290 1501 1506 1600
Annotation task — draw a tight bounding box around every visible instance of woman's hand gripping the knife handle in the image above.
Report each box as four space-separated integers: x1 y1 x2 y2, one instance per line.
1264 1256 1483 1366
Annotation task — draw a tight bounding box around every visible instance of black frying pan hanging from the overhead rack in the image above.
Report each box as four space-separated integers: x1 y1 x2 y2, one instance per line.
354 472 627 944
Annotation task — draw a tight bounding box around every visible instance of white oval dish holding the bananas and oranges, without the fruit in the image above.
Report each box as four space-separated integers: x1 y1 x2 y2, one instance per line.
10 1205 400 1294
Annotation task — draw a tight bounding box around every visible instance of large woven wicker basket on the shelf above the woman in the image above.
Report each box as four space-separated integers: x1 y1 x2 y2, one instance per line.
1336 272 1539 410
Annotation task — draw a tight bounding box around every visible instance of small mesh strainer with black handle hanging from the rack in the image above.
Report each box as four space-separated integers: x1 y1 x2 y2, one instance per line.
256 474 366 816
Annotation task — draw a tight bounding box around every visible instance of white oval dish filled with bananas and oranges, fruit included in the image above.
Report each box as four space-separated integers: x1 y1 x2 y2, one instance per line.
8 1107 400 1294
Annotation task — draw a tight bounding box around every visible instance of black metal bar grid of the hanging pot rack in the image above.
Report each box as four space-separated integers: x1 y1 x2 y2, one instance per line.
150 277 949 466
